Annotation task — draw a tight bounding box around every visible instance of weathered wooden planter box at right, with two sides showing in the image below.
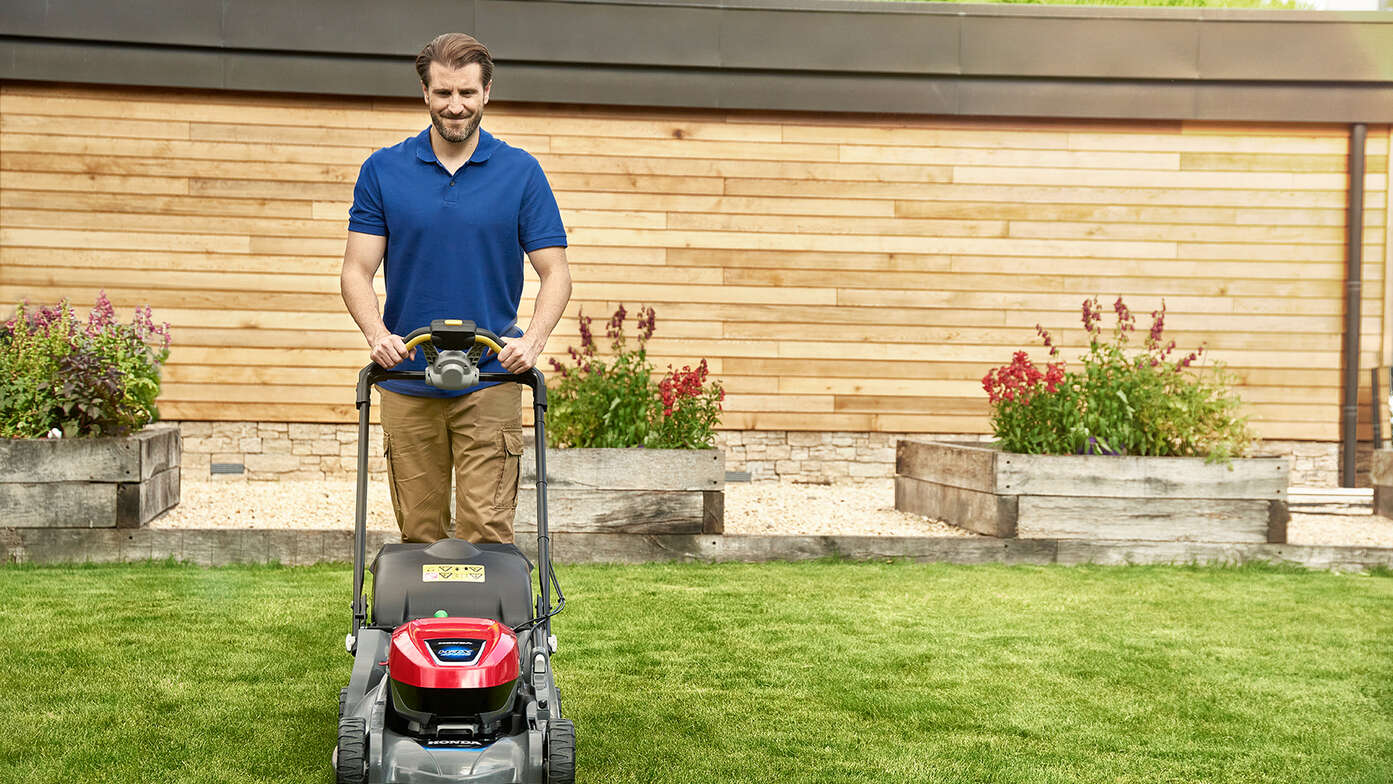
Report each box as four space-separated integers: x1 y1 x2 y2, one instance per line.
894 440 1291 543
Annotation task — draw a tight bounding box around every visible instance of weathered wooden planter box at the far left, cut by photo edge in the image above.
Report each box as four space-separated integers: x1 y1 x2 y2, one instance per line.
0 423 181 528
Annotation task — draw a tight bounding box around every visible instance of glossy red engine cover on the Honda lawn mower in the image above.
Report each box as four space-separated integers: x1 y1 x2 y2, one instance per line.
387 618 518 689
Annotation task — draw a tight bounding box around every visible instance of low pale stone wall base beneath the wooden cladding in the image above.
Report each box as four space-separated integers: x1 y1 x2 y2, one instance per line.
171 422 1348 487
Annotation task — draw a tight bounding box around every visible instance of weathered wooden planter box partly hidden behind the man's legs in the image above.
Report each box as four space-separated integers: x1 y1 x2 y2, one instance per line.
514 448 726 533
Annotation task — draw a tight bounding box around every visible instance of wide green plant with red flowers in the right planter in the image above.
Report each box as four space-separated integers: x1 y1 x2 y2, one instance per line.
982 298 1254 461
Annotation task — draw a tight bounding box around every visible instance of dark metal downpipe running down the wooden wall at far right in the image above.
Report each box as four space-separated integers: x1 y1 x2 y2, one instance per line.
1340 123 1368 487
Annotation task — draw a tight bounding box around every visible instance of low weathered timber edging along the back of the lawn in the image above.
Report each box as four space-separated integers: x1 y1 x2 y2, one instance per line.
0 528 1393 571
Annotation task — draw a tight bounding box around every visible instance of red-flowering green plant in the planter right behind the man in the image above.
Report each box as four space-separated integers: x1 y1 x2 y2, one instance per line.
547 305 724 448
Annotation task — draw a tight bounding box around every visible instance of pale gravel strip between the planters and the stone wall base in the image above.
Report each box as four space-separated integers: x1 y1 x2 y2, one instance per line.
149 479 1393 547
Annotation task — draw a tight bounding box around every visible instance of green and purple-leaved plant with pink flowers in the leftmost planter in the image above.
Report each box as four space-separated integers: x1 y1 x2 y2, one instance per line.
0 292 170 439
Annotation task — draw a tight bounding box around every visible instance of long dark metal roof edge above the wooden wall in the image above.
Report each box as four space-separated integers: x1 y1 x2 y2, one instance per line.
0 0 1393 123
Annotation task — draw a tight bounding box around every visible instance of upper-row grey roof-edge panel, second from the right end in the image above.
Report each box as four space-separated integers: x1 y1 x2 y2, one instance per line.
963 17 1199 79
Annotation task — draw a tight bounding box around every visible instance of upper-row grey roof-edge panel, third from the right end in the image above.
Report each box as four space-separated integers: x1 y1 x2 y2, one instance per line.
720 10 960 74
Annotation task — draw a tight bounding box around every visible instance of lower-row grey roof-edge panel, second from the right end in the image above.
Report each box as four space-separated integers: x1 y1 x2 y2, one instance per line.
958 79 1195 120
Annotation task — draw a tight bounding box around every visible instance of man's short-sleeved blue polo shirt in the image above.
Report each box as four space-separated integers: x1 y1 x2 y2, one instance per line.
348 128 566 397
